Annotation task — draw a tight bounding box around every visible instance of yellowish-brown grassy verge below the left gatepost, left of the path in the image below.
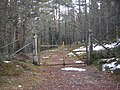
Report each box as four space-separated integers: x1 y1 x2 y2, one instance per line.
0 61 45 90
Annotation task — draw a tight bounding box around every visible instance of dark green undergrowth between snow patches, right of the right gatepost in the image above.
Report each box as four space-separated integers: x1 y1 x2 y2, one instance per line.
91 46 120 74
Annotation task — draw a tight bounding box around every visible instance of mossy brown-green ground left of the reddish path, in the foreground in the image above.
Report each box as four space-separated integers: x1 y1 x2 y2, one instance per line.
0 61 47 90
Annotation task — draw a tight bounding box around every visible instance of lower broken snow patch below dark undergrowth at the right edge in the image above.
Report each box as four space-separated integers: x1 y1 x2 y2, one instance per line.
102 58 120 73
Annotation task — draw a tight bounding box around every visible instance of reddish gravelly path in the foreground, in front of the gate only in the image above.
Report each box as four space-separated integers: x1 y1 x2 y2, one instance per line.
35 67 120 90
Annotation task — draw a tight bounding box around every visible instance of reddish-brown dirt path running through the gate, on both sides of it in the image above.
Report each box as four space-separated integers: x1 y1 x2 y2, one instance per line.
35 48 120 90
